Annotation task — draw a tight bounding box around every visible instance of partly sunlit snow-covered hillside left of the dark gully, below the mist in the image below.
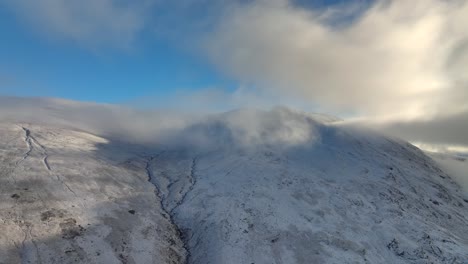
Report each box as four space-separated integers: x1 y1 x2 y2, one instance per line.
0 123 186 264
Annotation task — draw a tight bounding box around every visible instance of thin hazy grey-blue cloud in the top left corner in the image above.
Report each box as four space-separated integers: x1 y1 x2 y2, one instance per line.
0 0 153 48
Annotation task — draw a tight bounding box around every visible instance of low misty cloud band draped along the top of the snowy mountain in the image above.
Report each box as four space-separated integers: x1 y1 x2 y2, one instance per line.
0 96 322 149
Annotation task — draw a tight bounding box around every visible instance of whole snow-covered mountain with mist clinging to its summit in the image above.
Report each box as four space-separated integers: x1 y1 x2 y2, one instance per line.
0 98 468 264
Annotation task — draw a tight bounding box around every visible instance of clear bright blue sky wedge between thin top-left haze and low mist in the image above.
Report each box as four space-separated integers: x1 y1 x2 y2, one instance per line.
0 2 235 103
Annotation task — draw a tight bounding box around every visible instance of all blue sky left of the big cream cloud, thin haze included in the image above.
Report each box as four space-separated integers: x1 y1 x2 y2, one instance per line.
0 0 368 107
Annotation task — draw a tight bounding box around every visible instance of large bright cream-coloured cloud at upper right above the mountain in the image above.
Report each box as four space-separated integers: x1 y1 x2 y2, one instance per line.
203 0 468 120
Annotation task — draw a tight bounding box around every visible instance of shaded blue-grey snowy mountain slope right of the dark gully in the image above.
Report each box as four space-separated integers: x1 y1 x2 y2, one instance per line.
153 114 468 263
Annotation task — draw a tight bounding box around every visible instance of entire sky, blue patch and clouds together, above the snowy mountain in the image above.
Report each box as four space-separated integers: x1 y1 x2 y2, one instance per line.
0 0 468 151
